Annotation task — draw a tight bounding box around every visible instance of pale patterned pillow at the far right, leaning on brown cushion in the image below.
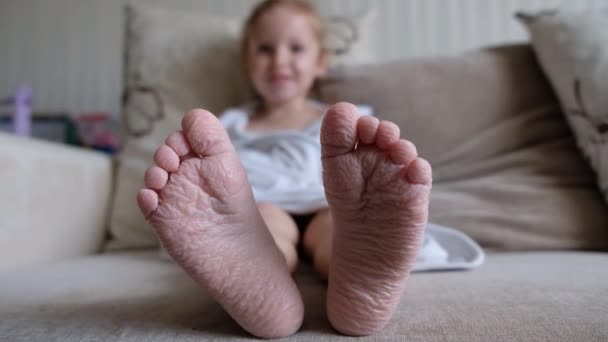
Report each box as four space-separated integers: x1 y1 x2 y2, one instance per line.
517 8 608 201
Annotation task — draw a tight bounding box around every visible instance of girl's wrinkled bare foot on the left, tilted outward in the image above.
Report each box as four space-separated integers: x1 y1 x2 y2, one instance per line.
138 110 304 337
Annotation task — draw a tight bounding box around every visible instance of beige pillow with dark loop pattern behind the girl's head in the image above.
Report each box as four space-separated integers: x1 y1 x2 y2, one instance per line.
107 2 373 248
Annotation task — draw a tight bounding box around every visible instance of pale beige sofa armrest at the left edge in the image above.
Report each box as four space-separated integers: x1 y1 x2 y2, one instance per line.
0 133 113 270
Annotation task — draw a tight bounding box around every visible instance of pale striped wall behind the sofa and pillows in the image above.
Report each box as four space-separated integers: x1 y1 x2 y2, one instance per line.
0 0 608 113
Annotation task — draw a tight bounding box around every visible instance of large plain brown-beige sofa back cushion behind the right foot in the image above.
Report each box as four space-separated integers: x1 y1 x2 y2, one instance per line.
320 45 608 250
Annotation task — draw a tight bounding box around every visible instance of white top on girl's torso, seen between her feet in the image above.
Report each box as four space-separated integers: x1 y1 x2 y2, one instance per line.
220 103 371 214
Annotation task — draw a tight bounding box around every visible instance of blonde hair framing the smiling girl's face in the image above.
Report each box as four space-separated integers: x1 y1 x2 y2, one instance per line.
240 0 329 99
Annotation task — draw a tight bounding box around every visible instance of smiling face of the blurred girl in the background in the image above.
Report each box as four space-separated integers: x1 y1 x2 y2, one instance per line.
247 6 326 105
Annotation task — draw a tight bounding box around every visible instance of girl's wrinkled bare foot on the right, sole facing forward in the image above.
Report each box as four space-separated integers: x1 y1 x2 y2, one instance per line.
321 103 431 335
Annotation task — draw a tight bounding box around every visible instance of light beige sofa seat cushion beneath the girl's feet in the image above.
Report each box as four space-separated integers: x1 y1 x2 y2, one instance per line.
0 251 608 342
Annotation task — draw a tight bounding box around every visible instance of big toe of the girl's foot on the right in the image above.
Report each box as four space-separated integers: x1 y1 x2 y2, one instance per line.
321 102 359 157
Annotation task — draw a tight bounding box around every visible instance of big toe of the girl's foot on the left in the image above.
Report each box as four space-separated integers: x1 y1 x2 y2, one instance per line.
182 109 234 157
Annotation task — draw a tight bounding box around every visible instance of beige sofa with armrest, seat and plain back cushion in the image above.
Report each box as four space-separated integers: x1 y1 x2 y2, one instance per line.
0 39 608 341
